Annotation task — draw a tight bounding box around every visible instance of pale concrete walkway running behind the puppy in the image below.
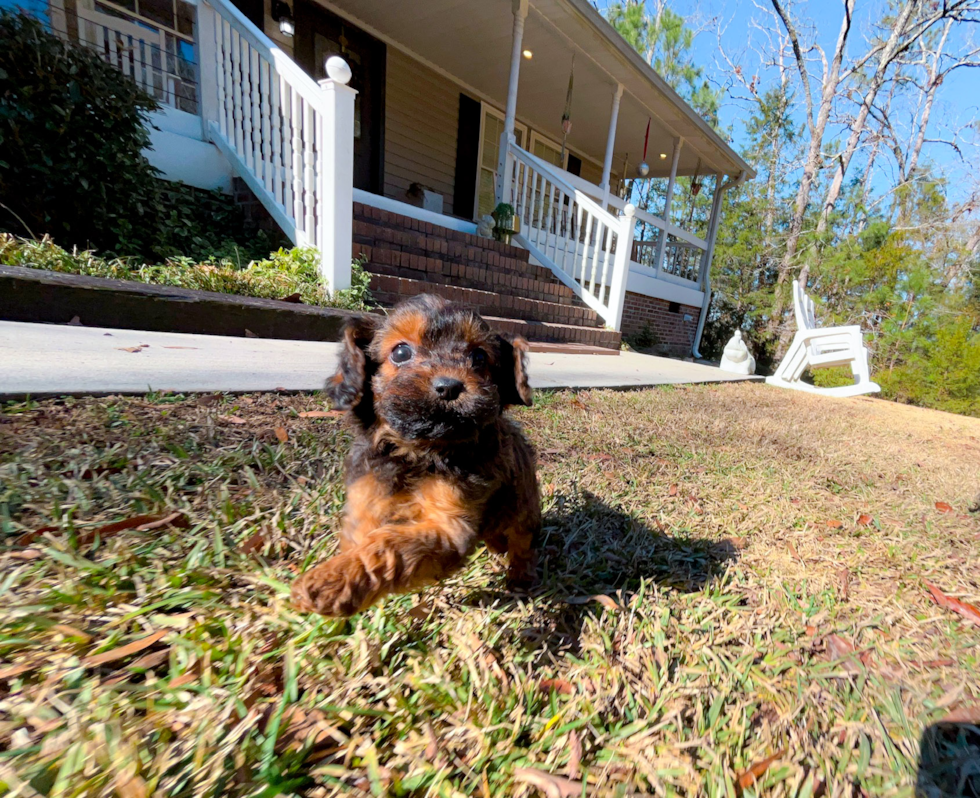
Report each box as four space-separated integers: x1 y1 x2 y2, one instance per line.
0 321 761 398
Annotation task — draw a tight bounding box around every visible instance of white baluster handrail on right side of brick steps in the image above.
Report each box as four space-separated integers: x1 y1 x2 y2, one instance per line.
504 141 636 330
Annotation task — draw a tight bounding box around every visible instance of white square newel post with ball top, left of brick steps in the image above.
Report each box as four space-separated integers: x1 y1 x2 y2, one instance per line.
316 56 357 293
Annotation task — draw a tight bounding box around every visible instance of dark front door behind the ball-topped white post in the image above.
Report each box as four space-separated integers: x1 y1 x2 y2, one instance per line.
295 0 386 194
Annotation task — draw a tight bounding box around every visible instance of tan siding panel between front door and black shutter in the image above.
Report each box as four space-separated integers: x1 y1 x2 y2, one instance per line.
384 47 459 213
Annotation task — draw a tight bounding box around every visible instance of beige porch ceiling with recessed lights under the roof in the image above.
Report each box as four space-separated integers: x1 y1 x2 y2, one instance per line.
310 0 754 177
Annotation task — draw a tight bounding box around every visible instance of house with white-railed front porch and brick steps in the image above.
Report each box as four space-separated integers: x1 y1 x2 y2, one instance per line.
40 0 754 356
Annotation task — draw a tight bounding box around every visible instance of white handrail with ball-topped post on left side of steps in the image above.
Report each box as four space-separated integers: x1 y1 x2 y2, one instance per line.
195 0 357 291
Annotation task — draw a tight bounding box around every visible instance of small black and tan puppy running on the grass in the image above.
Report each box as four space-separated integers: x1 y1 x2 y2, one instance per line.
292 295 541 615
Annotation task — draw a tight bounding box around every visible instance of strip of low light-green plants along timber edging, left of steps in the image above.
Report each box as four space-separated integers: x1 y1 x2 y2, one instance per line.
0 233 371 310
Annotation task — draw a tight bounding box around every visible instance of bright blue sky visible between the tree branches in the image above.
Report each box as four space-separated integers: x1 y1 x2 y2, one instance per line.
670 0 980 195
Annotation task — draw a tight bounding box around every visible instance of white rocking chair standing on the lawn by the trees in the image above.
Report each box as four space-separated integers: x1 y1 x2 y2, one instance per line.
766 280 881 396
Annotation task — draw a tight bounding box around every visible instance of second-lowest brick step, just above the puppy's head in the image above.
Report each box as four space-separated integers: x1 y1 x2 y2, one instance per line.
371 274 602 330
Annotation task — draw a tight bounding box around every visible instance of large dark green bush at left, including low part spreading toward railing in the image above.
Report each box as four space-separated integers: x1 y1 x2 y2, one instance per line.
0 11 278 263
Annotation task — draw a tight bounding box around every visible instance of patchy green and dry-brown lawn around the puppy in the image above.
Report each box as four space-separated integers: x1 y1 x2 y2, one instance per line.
0 384 980 798
